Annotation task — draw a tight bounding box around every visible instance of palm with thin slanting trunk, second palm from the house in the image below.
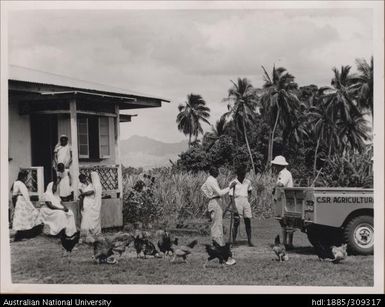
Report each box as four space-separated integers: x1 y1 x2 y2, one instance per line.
224 78 257 173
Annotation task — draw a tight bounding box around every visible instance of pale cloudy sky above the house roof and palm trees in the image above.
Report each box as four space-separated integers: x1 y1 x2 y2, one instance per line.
8 8 373 142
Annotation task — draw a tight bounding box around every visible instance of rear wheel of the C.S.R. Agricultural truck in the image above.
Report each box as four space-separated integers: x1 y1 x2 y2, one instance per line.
344 215 374 255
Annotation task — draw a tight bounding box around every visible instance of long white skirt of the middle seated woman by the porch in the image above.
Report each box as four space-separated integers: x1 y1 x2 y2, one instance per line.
40 206 77 236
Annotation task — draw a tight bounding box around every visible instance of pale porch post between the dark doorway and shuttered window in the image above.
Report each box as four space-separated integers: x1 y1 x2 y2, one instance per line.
70 98 79 200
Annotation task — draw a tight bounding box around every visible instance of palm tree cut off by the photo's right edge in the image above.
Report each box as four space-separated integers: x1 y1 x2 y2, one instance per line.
356 57 373 117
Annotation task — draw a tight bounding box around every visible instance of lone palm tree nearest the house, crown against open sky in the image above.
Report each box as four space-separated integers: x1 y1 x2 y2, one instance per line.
176 94 210 148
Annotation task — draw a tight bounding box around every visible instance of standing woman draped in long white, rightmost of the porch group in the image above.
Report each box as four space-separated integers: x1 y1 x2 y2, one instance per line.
80 172 102 237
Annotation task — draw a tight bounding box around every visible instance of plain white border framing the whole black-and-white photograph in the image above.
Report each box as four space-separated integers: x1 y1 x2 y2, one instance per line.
0 1 384 294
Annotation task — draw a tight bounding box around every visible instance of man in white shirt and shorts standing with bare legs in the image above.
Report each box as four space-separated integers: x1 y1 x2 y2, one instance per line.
229 166 254 246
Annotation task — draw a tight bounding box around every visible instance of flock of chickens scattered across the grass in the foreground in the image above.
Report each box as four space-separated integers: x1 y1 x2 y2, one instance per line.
60 230 347 267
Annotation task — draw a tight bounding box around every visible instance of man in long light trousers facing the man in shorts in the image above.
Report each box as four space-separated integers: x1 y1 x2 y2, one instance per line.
201 167 236 265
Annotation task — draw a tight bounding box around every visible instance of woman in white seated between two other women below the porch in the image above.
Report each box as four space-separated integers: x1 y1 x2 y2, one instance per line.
40 176 77 236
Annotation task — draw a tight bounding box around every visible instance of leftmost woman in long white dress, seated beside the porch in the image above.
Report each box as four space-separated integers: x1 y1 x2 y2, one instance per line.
12 171 43 241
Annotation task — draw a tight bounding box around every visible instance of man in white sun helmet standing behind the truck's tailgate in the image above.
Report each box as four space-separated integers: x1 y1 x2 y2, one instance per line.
271 156 294 248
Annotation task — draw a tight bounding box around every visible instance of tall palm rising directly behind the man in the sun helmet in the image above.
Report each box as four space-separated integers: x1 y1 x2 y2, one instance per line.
260 66 299 166
